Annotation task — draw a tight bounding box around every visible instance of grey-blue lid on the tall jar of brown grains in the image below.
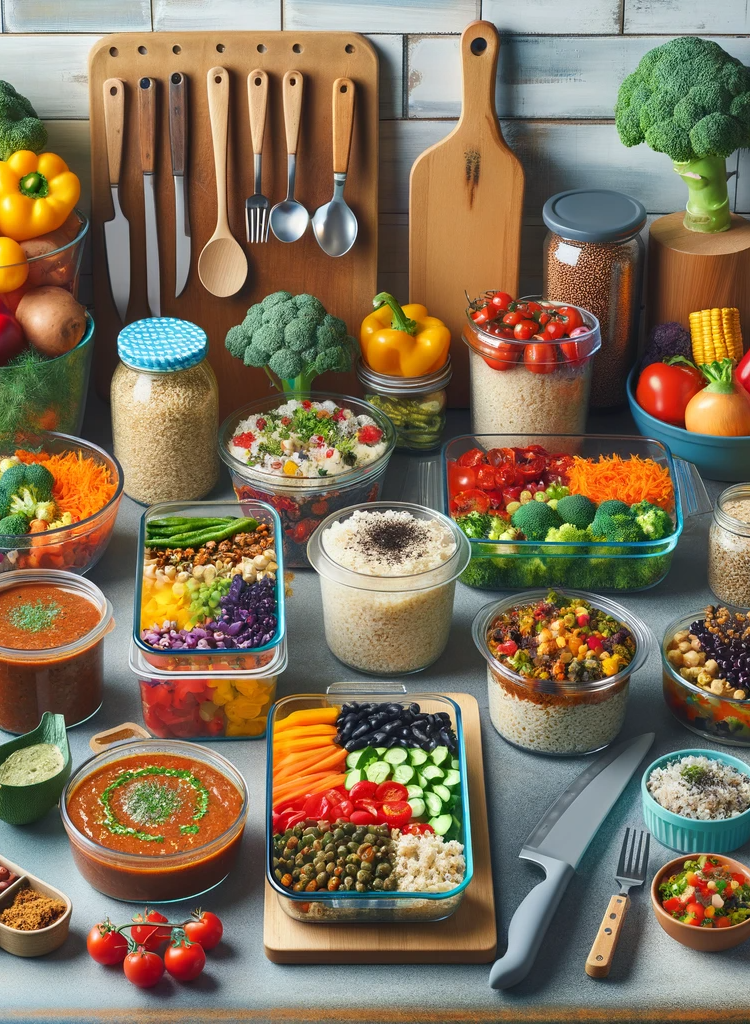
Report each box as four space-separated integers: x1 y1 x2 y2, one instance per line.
542 188 645 242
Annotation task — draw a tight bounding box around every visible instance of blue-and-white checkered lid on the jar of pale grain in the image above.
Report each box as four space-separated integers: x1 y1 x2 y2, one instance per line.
117 316 208 373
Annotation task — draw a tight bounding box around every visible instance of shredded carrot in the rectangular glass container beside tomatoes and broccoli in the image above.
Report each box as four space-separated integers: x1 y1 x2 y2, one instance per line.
568 455 674 512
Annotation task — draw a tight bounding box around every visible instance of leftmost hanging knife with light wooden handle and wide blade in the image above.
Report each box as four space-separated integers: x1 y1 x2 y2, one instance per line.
103 78 130 324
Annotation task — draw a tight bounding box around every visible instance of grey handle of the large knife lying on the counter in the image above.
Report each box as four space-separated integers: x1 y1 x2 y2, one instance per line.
490 854 576 988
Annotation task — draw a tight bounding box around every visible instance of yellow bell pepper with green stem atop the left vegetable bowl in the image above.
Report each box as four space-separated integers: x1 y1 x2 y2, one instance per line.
0 150 81 242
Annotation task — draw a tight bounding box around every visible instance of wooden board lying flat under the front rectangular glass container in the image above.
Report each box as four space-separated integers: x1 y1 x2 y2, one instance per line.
263 693 497 964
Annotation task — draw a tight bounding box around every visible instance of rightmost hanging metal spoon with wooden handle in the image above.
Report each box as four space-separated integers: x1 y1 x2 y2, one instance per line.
313 78 358 256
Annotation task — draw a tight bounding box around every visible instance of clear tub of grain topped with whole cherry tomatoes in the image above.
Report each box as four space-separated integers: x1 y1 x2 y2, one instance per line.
463 292 601 434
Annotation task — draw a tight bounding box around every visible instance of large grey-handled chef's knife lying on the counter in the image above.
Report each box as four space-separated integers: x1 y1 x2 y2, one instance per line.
490 732 655 988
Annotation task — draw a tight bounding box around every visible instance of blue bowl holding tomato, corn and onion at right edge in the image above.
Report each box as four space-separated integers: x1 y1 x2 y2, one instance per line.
627 367 750 481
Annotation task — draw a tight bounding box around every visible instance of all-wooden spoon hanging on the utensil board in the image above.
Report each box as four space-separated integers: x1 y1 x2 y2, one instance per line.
198 68 247 299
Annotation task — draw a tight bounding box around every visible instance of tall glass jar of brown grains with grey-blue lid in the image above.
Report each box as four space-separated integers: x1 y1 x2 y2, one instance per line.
542 188 645 410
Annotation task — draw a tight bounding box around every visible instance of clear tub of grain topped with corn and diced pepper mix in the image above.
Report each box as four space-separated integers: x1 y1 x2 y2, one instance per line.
472 590 650 756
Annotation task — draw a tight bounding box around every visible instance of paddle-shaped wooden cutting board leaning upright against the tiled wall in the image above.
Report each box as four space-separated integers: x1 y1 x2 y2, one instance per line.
409 22 524 407
